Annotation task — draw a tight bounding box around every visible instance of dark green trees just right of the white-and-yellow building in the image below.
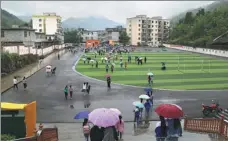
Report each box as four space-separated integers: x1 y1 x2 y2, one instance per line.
64 29 83 44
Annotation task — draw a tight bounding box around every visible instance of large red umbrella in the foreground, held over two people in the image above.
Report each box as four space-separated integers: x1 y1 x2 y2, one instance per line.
155 104 184 118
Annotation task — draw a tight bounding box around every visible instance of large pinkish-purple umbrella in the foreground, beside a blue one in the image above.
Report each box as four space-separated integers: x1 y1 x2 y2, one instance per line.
89 108 119 127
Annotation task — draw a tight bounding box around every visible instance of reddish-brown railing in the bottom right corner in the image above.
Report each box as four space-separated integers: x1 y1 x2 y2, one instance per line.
184 118 228 139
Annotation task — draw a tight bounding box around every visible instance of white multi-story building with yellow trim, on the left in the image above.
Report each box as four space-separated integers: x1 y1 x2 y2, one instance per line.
32 13 64 43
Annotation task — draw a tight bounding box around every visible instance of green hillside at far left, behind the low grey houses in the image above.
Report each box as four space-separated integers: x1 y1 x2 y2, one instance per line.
1 9 25 28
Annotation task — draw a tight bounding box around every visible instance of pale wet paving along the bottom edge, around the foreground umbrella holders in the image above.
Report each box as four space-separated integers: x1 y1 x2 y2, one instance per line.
41 121 225 141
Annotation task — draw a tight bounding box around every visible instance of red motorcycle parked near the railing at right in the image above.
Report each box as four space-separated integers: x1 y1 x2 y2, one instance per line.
202 101 223 116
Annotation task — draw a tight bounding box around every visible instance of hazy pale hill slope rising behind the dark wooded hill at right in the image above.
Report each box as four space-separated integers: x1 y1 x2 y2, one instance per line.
170 1 228 26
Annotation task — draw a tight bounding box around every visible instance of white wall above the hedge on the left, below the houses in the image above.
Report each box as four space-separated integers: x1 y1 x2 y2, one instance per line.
2 44 66 56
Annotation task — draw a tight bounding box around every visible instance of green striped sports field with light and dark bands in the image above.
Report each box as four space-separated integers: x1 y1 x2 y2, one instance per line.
76 51 228 90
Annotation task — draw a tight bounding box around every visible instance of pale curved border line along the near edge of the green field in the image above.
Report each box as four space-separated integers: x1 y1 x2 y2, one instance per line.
72 55 227 92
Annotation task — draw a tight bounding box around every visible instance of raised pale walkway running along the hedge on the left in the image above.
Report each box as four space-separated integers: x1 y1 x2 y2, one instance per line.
1 50 65 92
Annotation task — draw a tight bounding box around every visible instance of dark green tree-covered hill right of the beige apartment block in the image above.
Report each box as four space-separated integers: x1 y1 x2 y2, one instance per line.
169 2 228 47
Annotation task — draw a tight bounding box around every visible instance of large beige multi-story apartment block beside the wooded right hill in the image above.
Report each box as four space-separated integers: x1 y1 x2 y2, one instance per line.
126 15 170 46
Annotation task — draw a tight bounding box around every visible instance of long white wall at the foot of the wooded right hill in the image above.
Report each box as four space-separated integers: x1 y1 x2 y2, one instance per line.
163 44 228 57
